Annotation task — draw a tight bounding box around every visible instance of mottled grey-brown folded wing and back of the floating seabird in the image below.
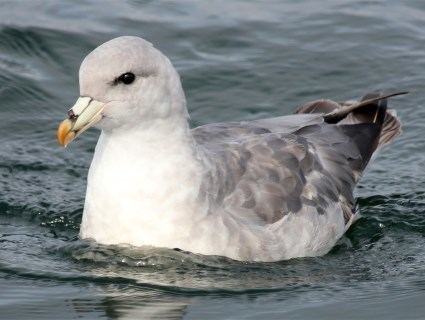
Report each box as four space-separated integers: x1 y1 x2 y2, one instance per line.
193 94 400 224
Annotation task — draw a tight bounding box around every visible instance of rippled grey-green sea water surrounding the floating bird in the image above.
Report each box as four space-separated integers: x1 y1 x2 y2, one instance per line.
0 0 425 320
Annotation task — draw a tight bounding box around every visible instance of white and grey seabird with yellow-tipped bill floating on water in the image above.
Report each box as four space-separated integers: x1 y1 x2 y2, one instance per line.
57 36 401 261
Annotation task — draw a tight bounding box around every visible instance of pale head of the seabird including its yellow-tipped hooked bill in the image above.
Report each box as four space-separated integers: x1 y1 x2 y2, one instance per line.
57 36 187 146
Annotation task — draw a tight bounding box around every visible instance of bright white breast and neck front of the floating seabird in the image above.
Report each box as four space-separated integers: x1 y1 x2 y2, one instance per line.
81 117 207 246
